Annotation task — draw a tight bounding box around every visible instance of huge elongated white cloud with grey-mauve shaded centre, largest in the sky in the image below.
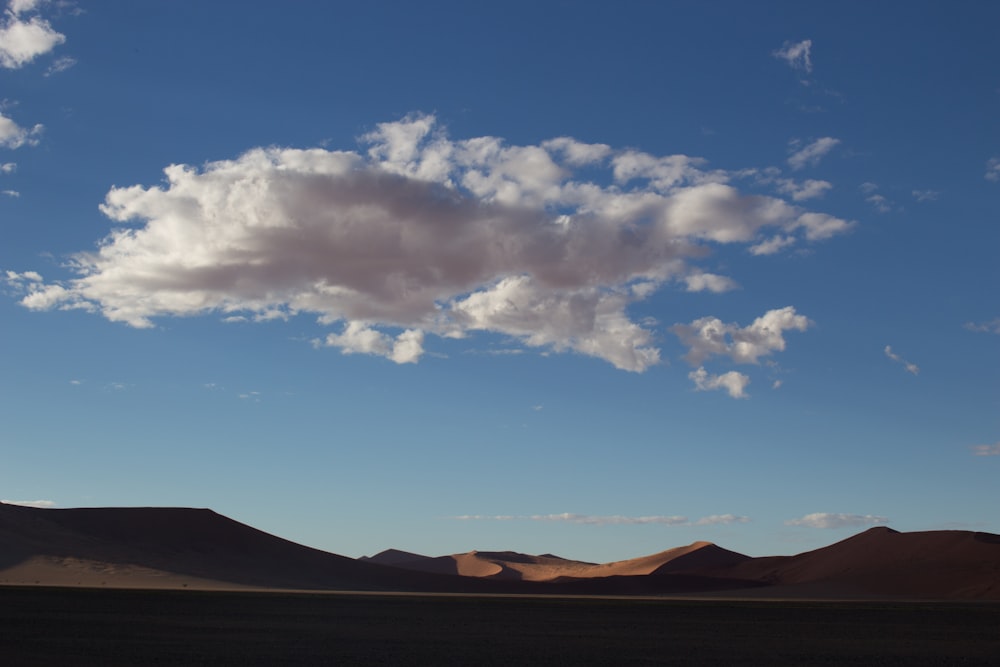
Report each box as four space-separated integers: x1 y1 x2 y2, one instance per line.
5 115 852 371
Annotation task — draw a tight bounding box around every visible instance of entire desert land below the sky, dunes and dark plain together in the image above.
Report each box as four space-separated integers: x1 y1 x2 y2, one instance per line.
0 505 1000 665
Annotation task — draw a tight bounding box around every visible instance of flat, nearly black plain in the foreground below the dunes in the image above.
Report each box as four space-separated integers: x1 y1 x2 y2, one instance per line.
0 587 1000 667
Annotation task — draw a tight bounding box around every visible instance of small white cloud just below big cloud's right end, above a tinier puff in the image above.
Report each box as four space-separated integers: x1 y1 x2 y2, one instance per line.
670 306 812 365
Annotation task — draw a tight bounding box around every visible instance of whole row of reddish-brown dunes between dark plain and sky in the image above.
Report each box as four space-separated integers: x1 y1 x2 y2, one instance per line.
0 503 1000 600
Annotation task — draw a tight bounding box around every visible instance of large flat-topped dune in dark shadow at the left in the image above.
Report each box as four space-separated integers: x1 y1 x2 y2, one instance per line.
0 503 760 594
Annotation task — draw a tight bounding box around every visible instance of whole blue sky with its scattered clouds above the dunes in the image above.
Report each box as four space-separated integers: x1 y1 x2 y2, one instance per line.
0 0 1000 562
